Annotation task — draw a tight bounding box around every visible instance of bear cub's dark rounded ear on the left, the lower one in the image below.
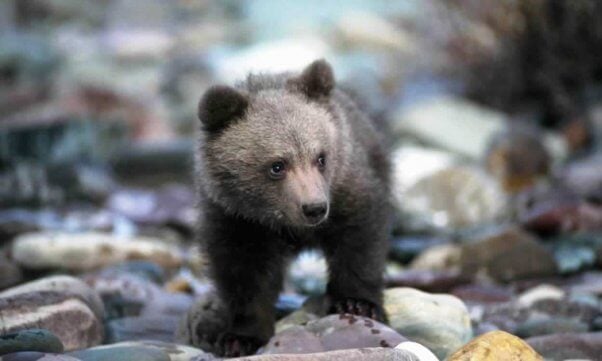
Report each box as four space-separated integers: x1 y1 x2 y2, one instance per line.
198 85 249 132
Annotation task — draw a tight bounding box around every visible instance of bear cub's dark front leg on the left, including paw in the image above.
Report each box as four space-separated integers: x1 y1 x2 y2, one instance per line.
197 214 284 357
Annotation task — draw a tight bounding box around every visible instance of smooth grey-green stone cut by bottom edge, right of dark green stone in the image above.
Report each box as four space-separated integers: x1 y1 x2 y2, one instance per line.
69 345 171 361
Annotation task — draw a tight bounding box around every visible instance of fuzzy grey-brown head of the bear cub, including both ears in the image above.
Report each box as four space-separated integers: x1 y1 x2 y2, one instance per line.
199 60 340 227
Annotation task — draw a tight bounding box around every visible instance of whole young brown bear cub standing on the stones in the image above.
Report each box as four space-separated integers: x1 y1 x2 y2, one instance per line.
194 60 390 357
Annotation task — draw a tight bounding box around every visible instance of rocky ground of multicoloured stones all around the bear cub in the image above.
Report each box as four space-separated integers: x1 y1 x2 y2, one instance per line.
0 0 602 361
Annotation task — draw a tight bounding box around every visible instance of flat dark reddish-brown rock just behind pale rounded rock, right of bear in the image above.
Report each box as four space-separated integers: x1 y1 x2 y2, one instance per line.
385 270 470 292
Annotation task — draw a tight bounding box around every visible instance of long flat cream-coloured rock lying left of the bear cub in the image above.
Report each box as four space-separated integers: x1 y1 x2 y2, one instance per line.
12 232 182 271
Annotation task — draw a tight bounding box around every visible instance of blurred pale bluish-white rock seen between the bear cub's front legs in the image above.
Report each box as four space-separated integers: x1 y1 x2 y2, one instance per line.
288 251 328 295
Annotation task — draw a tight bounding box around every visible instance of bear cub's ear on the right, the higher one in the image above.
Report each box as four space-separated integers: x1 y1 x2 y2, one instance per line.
288 59 334 100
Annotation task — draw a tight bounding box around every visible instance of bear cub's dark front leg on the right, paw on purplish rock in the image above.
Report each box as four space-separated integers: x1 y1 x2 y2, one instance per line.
324 215 388 323
